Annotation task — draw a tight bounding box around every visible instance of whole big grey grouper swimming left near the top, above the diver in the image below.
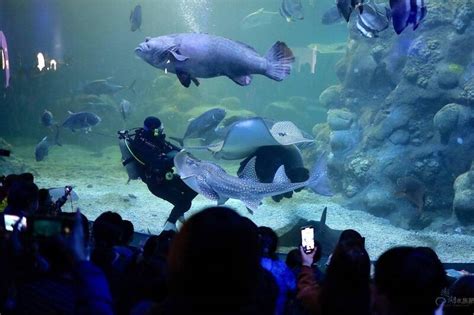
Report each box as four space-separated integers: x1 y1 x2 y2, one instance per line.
135 33 295 87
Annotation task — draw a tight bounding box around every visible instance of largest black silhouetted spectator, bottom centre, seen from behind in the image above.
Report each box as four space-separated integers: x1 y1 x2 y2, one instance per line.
154 207 276 314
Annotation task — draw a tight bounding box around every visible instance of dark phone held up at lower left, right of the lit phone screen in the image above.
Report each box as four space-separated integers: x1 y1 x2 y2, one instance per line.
28 216 74 238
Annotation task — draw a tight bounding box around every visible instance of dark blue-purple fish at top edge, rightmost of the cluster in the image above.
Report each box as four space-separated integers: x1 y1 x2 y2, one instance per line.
390 0 427 34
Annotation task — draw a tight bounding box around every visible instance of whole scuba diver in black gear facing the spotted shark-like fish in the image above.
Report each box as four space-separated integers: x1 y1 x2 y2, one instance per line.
118 116 198 230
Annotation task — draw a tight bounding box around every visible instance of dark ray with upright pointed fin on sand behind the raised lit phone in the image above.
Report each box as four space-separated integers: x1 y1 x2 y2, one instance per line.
276 207 342 257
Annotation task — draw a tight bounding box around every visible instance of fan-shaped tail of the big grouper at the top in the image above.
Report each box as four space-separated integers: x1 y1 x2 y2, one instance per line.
265 41 295 81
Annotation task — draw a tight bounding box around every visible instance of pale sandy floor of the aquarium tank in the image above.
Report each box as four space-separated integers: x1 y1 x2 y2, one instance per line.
10 145 474 263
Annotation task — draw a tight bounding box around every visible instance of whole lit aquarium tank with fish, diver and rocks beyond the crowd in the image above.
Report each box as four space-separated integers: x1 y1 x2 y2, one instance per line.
0 0 474 263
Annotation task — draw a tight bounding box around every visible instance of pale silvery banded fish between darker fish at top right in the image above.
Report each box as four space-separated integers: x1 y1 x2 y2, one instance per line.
356 1 392 38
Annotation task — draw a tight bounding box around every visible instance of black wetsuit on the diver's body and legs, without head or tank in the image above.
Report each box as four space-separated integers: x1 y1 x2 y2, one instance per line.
130 129 198 224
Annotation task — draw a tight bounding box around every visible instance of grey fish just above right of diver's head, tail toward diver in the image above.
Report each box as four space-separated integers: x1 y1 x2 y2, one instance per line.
170 108 226 146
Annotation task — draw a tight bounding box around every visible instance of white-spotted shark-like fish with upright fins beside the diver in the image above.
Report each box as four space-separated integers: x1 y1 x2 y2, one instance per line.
174 150 332 211
